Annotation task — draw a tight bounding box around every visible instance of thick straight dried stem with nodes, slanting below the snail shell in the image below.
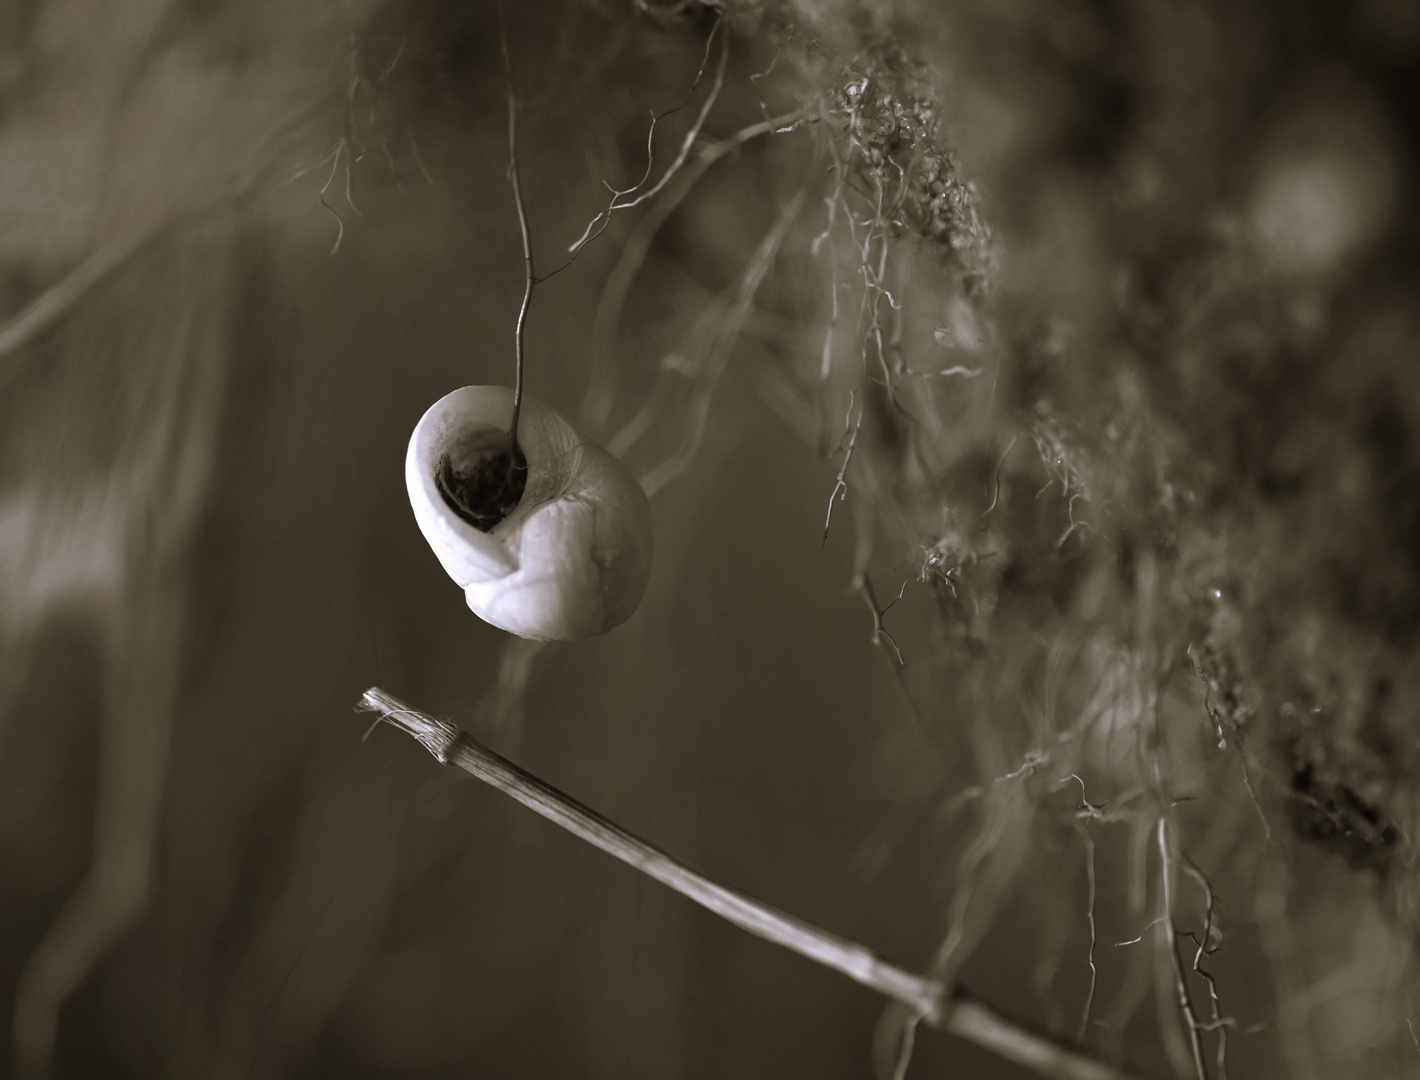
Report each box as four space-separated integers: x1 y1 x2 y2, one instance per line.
356 687 1147 1080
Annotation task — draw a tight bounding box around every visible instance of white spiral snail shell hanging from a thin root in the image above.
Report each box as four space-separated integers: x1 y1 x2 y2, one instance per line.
405 386 652 641
